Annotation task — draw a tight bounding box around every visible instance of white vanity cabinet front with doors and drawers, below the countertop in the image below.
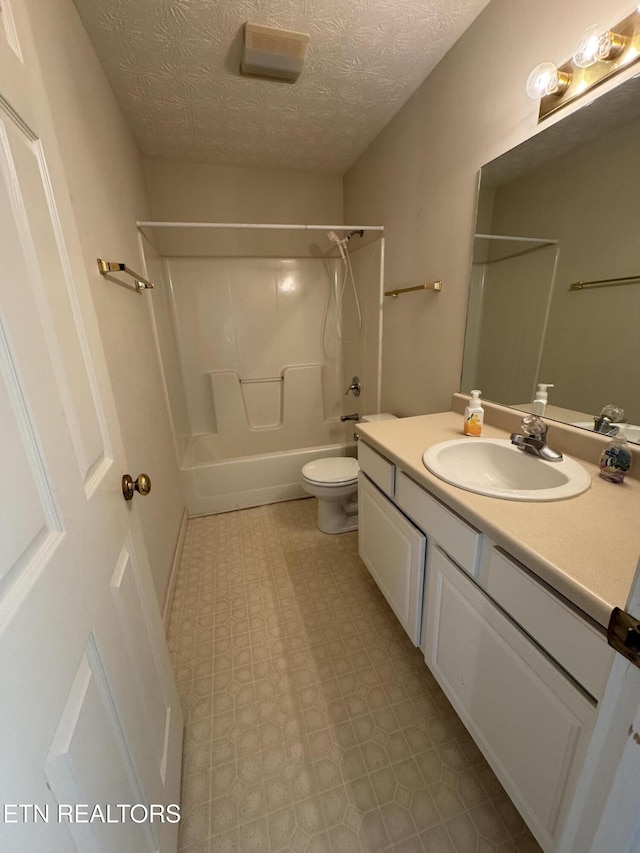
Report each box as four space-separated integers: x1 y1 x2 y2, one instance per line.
359 439 613 853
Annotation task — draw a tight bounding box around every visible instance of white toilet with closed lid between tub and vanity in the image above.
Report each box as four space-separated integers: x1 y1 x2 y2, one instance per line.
301 412 395 533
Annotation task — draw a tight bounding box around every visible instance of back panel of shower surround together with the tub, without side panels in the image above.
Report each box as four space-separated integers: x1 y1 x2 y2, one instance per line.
166 258 360 516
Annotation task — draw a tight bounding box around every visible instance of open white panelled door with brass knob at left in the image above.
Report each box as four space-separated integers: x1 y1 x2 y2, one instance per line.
0 0 182 853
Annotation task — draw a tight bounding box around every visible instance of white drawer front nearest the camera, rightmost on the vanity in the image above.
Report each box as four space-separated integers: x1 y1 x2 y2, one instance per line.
482 548 614 699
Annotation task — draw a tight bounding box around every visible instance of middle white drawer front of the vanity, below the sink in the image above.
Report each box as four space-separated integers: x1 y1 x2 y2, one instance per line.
396 473 482 575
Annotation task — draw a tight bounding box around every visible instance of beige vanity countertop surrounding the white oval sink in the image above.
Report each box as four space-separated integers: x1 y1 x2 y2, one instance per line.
358 412 640 628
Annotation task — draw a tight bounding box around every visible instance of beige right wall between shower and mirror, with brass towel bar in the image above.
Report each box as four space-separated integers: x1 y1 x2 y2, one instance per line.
345 0 634 415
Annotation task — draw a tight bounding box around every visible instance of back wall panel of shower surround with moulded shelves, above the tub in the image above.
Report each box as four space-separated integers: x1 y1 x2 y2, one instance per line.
165 258 344 442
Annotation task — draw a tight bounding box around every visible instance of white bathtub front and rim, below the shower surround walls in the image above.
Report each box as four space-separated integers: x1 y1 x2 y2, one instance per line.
180 442 357 517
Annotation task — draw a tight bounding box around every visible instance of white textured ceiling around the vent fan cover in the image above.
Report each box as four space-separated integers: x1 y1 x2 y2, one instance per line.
74 0 488 172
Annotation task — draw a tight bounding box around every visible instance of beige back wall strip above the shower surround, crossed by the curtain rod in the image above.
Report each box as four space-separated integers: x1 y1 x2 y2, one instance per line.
144 160 343 257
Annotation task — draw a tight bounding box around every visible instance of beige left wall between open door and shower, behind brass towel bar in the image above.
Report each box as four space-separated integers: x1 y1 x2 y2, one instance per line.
26 0 184 603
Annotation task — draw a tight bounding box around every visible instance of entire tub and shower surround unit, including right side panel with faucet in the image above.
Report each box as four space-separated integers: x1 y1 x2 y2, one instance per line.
149 225 381 516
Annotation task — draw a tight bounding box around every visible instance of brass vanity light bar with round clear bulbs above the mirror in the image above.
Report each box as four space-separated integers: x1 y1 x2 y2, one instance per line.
527 3 640 121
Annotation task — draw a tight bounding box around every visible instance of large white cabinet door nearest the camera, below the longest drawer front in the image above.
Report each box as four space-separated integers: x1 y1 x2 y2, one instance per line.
426 548 595 850
